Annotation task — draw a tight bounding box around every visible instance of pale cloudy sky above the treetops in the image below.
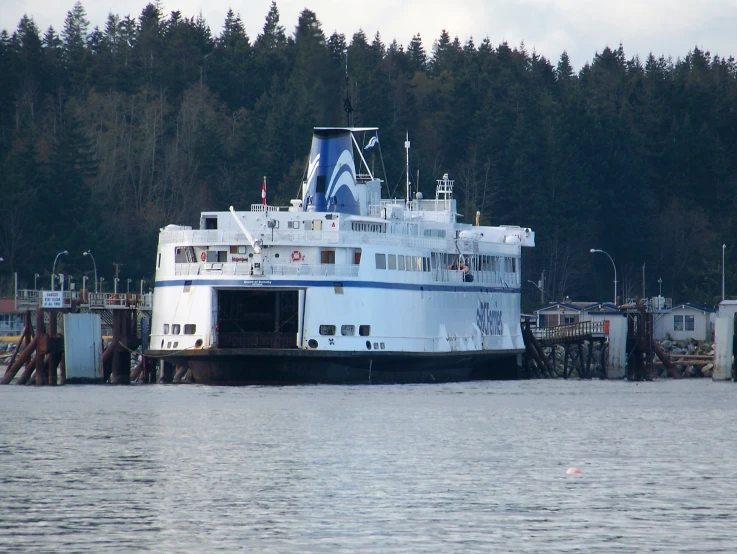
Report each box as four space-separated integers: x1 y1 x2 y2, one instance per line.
0 0 737 70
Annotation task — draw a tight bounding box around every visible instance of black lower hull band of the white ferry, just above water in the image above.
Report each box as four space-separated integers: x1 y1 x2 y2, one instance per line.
146 348 521 385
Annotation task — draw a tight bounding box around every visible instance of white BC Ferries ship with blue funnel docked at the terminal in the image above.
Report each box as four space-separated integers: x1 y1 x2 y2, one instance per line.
146 127 535 384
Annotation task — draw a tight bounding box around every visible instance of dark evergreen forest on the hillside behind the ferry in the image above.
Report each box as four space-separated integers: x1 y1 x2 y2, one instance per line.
0 2 737 310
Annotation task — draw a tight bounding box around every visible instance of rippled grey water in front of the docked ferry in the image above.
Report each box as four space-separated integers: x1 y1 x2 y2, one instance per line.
0 380 737 553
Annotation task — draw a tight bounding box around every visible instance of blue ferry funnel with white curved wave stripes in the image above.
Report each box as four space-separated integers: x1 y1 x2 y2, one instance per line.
302 129 360 214
